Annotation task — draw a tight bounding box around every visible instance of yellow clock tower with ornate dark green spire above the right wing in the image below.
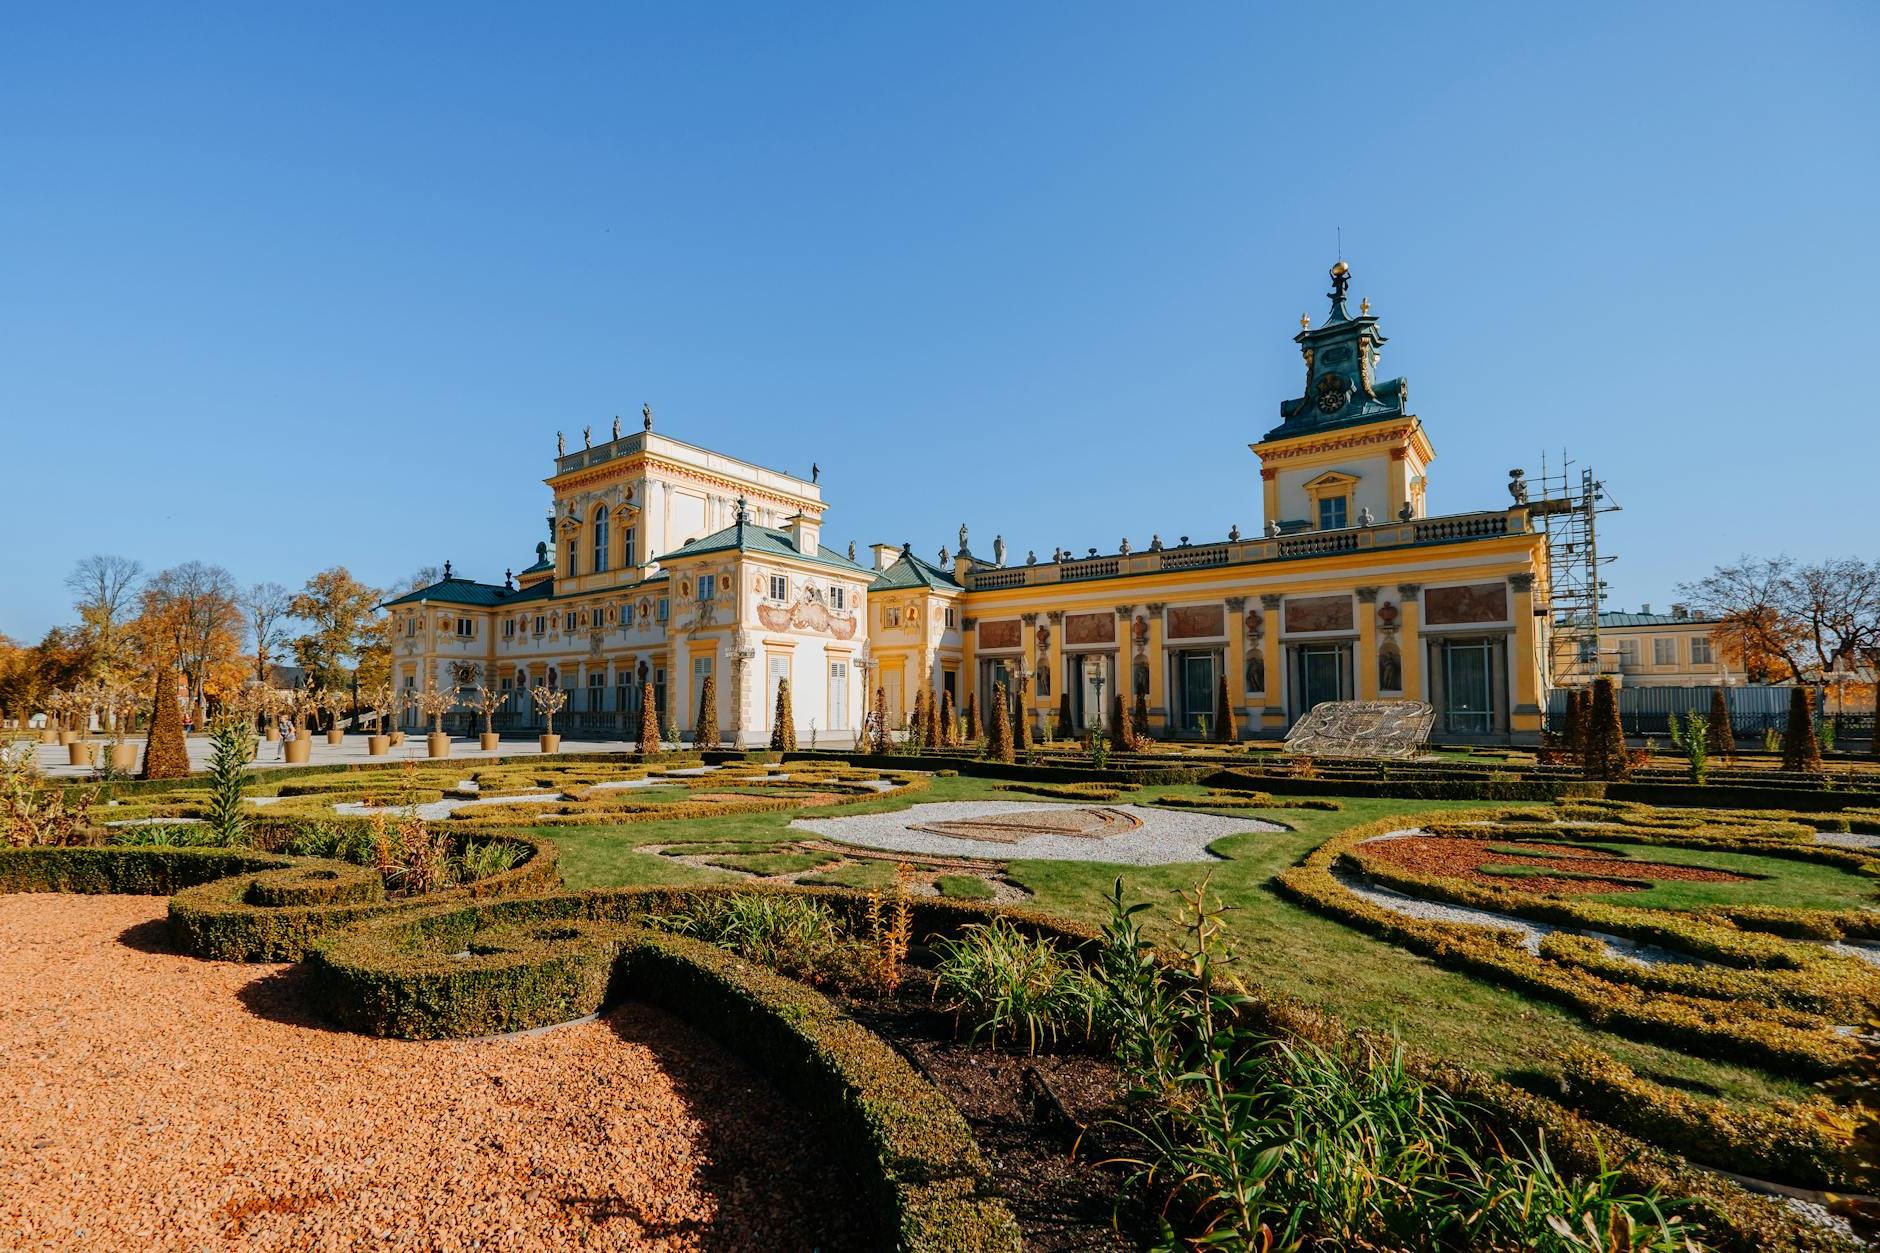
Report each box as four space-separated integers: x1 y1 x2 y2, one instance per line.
1252 262 1436 534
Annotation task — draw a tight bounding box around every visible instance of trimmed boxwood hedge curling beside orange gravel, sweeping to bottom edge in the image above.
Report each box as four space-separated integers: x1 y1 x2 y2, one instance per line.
312 892 1021 1253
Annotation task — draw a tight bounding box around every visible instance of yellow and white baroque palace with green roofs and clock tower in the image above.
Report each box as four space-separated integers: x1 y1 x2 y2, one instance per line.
385 262 1549 747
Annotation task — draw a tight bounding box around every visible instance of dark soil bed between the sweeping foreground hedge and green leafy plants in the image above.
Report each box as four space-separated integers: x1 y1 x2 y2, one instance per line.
844 993 1154 1253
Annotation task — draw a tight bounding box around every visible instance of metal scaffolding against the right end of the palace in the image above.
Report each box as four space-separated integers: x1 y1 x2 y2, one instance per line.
1528 450 1619 703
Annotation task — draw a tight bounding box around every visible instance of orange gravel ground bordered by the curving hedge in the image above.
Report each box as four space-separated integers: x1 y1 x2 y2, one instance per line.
0 894 854 1251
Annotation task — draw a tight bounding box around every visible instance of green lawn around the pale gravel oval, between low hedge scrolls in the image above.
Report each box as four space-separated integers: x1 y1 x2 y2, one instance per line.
538 777 1839 1104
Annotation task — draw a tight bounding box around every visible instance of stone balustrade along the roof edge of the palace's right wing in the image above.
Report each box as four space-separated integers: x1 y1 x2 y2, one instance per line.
966 508 1530 591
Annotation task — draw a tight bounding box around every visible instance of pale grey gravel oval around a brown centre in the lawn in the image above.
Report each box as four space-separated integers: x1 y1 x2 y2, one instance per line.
790 801 1286 865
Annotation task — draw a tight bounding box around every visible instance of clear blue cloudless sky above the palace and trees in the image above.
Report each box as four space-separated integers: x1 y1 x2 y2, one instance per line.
0 2 1880 638
